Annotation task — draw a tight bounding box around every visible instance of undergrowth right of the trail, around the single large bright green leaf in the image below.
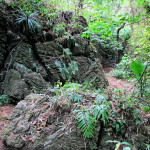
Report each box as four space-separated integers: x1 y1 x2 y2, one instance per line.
108 54 150 98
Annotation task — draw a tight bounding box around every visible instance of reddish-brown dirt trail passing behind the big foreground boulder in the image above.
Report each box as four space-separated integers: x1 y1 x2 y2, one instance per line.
0 67 134 150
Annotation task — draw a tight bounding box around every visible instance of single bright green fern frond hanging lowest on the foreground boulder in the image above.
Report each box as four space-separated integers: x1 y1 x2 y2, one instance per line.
74 109 95 138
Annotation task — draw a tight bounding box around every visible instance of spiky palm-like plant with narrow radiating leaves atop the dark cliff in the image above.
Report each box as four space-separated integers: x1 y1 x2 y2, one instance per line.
17 11 40 34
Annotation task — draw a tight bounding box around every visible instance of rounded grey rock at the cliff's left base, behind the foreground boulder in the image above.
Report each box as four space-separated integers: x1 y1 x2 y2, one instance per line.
3 65 48 100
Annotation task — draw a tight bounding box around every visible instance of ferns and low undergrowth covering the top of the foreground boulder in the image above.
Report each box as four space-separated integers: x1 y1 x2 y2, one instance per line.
52 82 150 149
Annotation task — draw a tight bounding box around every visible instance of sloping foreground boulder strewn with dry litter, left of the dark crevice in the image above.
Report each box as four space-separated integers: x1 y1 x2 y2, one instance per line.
1 94 96 150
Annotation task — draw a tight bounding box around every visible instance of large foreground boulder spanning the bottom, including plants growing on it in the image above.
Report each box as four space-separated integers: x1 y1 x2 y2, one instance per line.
0 83 150 150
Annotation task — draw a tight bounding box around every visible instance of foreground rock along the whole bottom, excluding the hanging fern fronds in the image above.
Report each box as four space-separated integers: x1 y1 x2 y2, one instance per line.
0 83 149 150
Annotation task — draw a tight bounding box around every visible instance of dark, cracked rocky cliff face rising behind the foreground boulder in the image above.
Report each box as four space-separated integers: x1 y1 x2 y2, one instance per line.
0 3 108 101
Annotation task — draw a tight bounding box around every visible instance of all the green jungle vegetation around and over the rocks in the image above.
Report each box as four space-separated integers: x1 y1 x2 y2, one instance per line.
0 0 150 150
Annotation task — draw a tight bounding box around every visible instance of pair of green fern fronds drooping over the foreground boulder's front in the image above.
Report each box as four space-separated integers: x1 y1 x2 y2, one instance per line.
74 95 109 138
